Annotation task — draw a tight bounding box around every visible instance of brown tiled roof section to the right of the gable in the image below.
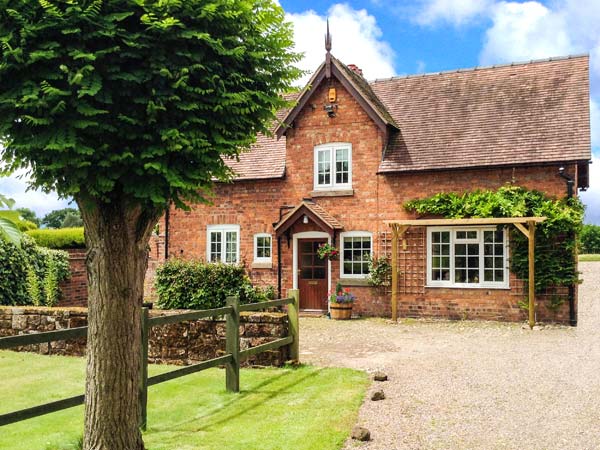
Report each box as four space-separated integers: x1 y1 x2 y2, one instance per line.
371 56 591 172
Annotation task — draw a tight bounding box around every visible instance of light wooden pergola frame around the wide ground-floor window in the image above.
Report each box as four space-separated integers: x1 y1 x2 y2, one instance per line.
384 217 546 328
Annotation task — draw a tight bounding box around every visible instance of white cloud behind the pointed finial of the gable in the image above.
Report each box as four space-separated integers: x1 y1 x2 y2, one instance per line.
286 4 395 85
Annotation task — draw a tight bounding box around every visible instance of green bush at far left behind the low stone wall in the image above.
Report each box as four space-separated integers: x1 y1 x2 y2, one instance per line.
0 235 70 306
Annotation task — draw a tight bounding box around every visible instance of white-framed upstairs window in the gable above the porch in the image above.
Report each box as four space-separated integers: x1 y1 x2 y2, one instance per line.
314 143 352 190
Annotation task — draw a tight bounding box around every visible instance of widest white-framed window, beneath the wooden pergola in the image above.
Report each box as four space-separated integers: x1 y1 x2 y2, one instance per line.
427 227 509 288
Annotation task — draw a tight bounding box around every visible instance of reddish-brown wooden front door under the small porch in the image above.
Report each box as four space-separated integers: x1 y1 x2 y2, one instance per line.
298 239 328 310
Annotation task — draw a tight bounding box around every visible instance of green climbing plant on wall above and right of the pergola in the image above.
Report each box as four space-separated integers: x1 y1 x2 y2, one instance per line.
405 185 583 292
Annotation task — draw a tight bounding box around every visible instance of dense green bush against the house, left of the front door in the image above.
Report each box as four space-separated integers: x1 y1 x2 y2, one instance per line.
155 259 275 309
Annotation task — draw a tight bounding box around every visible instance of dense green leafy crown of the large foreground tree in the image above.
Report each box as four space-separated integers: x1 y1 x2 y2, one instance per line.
0 0 300 213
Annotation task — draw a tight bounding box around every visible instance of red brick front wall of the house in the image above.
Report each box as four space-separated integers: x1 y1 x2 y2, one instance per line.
158 76 576 320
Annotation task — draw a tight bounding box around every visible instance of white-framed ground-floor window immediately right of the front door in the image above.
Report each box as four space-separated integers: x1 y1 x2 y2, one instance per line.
340 231 373 278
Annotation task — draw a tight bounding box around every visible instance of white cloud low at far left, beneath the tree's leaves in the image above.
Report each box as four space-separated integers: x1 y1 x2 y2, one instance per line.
0 171 73 217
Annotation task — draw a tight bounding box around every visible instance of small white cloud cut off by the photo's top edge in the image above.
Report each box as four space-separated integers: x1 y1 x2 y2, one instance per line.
415 0 493 26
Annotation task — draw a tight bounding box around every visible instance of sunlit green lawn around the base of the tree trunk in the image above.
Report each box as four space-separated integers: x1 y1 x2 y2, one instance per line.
0 351 369 450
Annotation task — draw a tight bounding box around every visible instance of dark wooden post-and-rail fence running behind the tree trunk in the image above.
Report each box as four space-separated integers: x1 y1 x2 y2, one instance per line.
0 289 300 429
